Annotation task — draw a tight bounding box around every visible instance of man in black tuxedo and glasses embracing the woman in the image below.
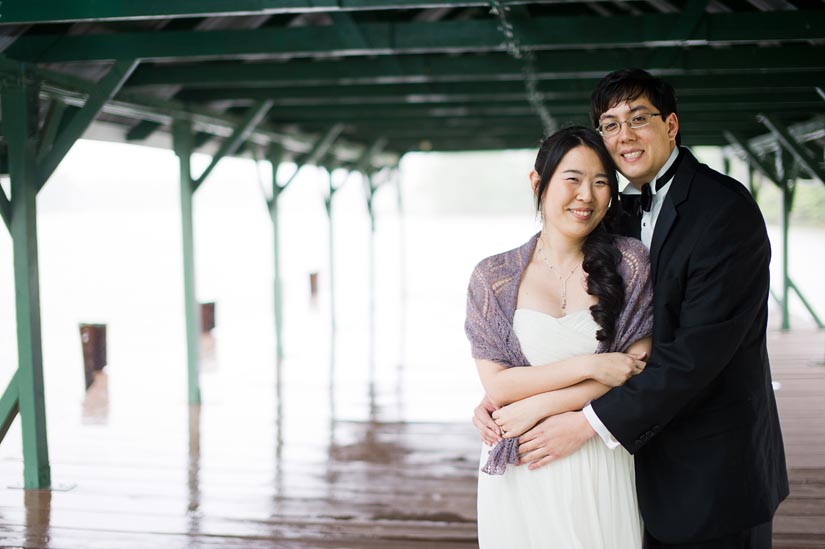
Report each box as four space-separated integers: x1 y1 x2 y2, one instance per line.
475 69 788 549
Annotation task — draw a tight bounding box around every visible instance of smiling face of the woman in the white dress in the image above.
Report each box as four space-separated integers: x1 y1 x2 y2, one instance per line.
542 145 610 240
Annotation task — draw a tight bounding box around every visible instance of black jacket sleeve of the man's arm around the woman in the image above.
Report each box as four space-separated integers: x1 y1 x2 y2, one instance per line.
592 202 770 453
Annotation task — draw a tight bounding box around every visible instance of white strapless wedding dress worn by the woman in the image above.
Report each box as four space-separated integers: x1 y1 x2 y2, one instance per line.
478 309 642 549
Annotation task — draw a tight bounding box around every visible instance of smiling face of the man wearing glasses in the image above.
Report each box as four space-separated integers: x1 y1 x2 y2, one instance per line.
599 95 679 188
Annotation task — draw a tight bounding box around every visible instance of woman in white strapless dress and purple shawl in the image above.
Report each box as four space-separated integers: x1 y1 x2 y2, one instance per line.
465 127 652 549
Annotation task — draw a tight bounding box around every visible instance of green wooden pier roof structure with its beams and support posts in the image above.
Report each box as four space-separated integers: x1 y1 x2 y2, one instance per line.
0 0 825 494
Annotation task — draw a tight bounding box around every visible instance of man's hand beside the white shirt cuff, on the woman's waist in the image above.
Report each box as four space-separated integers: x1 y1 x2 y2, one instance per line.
518 412 596 470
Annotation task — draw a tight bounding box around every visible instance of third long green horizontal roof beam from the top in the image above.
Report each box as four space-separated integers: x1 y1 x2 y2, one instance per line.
126 44 825 88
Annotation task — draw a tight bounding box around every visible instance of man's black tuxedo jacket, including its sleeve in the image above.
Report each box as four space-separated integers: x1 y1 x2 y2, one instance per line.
593 150 788 543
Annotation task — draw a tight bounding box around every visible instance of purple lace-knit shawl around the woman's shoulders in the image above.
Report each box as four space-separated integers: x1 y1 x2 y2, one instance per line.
464 233 653 475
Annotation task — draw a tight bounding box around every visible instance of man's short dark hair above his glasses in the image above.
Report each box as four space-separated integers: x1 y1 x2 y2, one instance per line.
590 69 682 146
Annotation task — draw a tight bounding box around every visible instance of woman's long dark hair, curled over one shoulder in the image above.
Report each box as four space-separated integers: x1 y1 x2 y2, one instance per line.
535 126 624 342
